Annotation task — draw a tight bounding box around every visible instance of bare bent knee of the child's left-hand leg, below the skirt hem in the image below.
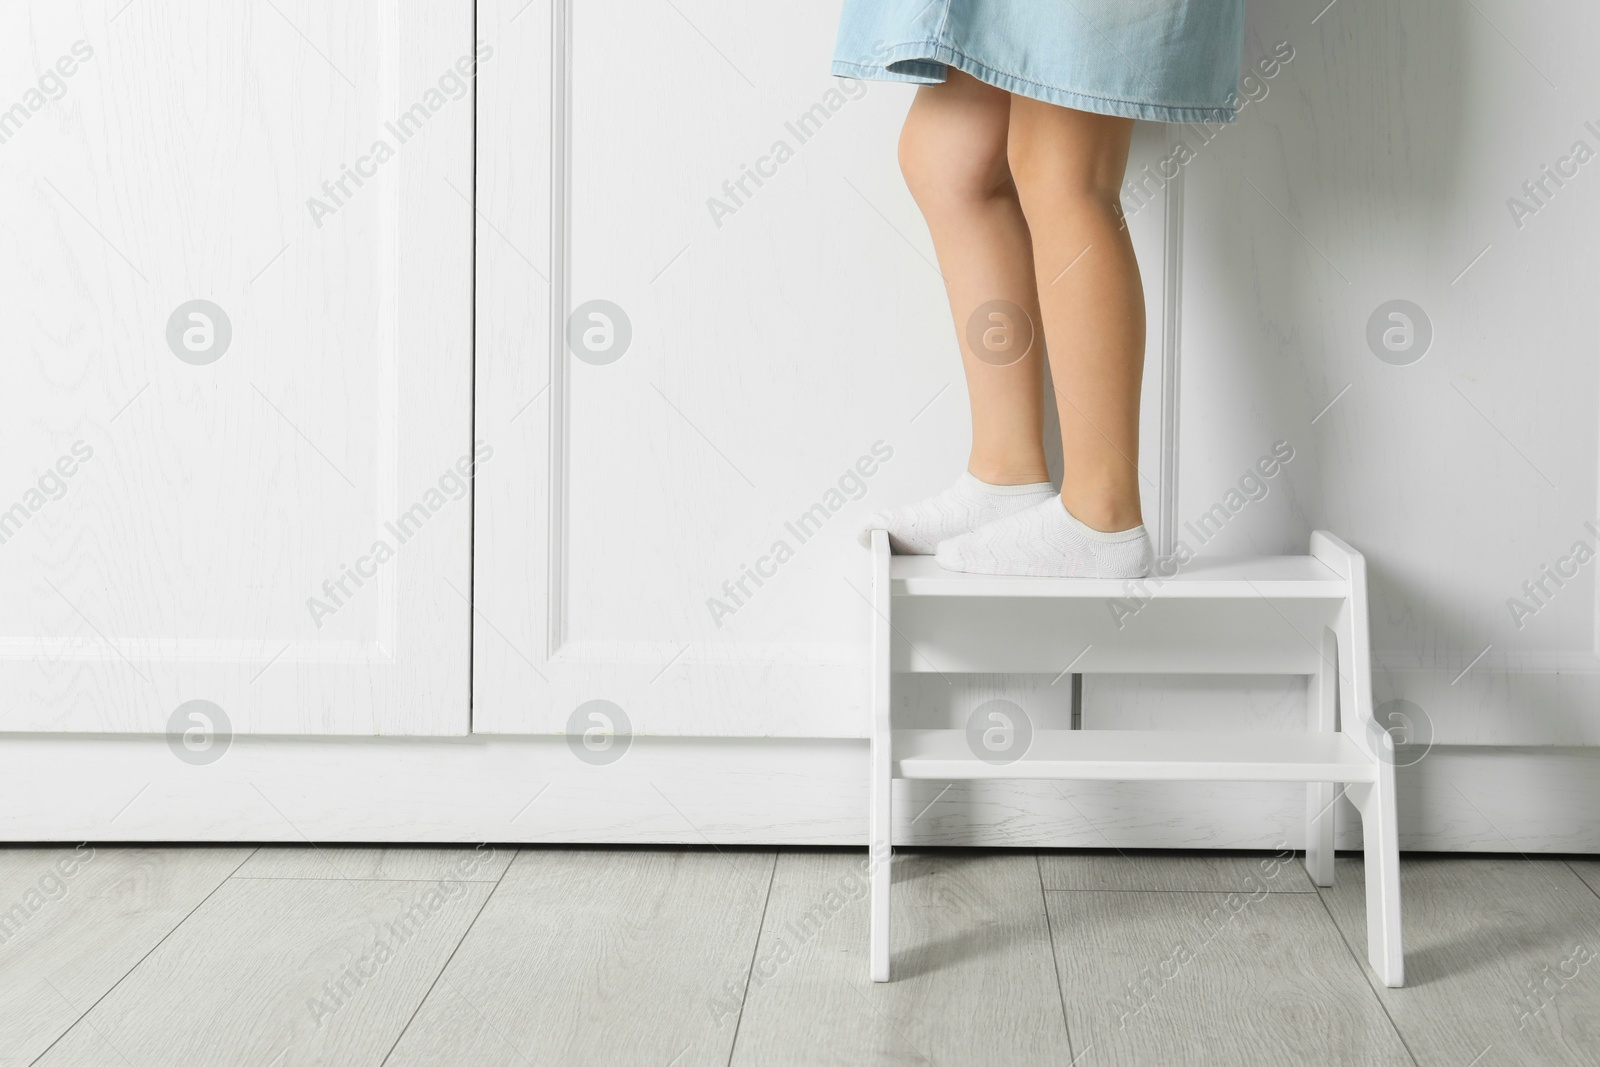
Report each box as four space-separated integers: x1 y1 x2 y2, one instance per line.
899 86 1013 213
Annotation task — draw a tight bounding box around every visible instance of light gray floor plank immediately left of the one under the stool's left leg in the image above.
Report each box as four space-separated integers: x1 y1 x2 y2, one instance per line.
386 848 774 1067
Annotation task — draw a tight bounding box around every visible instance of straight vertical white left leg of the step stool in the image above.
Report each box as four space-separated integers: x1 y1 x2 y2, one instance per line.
867 530 894 982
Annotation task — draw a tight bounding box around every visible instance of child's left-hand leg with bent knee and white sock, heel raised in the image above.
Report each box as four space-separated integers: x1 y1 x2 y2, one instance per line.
869 69 1054 553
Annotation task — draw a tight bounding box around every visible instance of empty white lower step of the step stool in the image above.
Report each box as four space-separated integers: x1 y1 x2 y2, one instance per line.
891 729 1378 782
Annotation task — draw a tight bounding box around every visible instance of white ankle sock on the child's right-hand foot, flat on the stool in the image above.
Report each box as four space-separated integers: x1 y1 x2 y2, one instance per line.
934 496 1154 577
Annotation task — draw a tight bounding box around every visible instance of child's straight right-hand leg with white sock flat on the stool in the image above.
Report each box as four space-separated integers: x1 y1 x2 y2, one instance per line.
938 96 1152 577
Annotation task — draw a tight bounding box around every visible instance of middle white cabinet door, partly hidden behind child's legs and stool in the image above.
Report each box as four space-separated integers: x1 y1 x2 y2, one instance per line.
474 0 1165 735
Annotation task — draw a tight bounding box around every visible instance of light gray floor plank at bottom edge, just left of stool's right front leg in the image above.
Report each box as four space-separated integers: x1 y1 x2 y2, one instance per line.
1046 891 1408 1067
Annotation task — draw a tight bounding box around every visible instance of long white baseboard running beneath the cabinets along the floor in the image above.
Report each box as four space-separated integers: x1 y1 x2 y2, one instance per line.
0 734 1600 854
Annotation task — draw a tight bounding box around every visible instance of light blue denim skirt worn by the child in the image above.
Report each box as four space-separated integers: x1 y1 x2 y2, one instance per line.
834 0 1245 122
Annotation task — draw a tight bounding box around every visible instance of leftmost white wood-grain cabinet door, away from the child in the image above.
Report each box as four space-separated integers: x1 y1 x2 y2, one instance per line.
0 0 473 734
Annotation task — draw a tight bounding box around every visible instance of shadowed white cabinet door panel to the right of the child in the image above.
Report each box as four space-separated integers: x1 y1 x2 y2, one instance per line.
1181 0 1600 744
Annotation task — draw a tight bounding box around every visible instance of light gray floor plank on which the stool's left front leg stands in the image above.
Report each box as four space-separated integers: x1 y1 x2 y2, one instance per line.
733 849 1072 1067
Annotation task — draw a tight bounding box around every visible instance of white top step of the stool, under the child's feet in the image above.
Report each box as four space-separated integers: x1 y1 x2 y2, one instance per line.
890 555 1349 600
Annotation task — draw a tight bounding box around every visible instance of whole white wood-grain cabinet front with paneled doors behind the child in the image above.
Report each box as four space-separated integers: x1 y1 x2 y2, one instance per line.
0 0 1600 758
